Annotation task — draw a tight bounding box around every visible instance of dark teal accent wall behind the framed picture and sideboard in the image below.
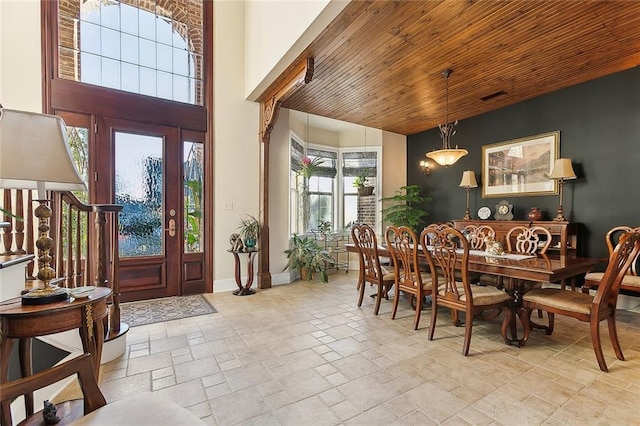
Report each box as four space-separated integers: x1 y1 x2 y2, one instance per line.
407 67 640 257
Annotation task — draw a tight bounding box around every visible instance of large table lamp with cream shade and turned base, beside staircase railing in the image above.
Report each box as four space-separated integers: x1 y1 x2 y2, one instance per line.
0 108 87 305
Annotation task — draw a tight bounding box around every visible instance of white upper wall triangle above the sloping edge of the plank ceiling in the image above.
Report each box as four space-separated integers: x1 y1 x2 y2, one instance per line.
244 0 349 100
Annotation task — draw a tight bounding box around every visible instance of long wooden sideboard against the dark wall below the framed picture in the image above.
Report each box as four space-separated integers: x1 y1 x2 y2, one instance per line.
453 219 580 256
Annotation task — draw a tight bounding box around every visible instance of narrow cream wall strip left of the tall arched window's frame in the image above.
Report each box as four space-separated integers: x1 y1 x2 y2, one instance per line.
0 0 42 112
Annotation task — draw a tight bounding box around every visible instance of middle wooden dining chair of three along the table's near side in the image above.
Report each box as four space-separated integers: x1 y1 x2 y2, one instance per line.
385 226 432 330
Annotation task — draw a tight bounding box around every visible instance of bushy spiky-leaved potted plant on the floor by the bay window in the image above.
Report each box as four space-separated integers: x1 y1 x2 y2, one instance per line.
282 234 334 283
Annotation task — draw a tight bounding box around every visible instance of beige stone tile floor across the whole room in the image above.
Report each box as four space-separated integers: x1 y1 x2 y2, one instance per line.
92 271 640 425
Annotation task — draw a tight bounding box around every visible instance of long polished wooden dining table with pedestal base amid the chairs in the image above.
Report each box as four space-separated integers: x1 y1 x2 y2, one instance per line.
345 244 602 346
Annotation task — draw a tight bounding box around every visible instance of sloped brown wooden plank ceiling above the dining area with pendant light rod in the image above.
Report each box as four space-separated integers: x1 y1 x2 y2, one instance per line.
260 0 640 135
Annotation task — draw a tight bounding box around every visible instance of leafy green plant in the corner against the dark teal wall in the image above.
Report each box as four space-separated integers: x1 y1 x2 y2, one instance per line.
382 185 431 232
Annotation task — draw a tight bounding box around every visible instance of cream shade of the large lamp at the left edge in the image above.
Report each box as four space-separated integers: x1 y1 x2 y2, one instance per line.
0 108 87 197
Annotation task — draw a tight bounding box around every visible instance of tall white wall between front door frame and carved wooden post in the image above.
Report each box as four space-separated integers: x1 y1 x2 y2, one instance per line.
213 1 260 291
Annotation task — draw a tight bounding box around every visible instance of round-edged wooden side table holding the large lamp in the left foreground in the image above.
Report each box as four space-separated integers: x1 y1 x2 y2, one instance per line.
0 287 111 425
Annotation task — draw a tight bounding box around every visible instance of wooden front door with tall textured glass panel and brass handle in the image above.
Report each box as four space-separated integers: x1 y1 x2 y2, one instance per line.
97 119 183 301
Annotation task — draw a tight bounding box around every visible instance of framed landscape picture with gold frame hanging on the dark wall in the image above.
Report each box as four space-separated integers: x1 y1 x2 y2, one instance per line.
482 131 560 197
